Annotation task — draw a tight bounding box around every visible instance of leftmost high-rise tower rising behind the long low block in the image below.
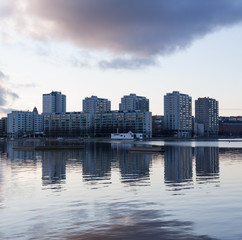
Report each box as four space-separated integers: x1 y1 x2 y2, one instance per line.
43 91 66 113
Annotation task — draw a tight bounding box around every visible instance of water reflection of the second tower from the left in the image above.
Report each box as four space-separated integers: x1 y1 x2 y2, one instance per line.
82 142 112 183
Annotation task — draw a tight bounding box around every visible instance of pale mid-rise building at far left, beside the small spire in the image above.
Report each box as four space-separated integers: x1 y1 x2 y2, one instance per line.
7 111 43 138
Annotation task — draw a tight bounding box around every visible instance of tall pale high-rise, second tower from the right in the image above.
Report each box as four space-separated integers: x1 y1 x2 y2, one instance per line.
164 91 192 137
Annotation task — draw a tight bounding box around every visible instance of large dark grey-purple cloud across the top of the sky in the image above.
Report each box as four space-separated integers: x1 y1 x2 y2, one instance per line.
22 0 242 57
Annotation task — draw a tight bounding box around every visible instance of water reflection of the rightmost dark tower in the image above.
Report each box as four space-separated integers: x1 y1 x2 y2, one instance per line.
195 147 219 182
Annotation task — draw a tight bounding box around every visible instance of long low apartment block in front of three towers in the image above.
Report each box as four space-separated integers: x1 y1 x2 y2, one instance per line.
43 111 152 138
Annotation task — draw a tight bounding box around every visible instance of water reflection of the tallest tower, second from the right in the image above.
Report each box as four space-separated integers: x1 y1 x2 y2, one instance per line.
164 146 192 186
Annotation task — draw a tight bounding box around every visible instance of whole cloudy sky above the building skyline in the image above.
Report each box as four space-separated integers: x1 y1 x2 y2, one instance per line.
0 0 242 116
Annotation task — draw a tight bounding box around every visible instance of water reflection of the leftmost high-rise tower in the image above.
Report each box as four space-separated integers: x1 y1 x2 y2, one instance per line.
42 151 68 187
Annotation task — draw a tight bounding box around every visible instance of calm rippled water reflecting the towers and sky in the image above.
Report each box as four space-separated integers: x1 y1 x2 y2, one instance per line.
0 140 242 240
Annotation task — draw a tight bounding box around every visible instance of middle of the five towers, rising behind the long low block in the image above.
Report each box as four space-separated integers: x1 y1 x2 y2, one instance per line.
119 93 149 112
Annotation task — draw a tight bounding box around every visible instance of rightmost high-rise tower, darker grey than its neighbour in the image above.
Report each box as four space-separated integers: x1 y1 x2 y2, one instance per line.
195 97 219 137
